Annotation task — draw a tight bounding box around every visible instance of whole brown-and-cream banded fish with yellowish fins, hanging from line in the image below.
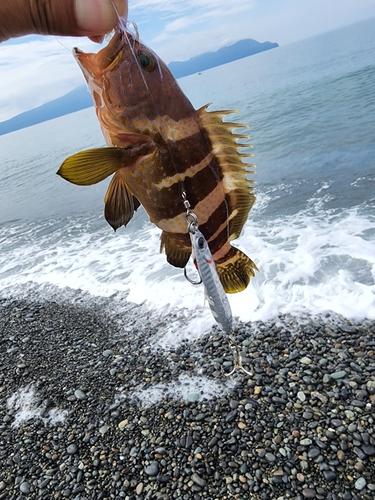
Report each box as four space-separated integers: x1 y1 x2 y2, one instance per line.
57 23 257 293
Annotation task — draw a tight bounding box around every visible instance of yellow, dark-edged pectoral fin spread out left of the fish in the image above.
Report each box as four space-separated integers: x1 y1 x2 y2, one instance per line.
57 142 155 186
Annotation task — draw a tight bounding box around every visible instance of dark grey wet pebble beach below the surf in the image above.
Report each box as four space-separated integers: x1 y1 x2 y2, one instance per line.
0 298 375 500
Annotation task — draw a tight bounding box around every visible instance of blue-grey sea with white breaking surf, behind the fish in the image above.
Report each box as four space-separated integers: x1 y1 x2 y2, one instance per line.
0 19 375 346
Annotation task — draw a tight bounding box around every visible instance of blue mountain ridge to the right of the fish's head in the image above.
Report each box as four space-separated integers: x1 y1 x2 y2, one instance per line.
169 38 279 78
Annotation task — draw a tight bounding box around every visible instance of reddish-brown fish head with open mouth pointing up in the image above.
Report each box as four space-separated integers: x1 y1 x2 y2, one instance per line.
74 26 193 141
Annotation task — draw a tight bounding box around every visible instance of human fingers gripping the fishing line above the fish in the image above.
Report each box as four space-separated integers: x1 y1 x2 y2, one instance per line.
0 0 128 42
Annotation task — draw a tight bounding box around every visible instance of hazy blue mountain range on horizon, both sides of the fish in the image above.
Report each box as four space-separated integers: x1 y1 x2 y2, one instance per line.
0 39 278 135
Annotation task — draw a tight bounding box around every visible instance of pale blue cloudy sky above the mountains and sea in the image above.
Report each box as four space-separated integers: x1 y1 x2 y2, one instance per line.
0 0 375 122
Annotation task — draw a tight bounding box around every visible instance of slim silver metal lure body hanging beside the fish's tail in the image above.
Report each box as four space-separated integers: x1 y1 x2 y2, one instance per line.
189 229 233 335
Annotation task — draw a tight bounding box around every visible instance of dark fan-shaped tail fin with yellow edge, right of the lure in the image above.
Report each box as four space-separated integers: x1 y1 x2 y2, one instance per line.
216 247 258 293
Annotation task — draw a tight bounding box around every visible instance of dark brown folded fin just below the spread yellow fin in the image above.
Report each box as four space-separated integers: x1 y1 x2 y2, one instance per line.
104 172 140 231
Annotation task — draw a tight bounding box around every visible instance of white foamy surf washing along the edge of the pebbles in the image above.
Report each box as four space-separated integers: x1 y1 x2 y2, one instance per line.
0 192 375 328
